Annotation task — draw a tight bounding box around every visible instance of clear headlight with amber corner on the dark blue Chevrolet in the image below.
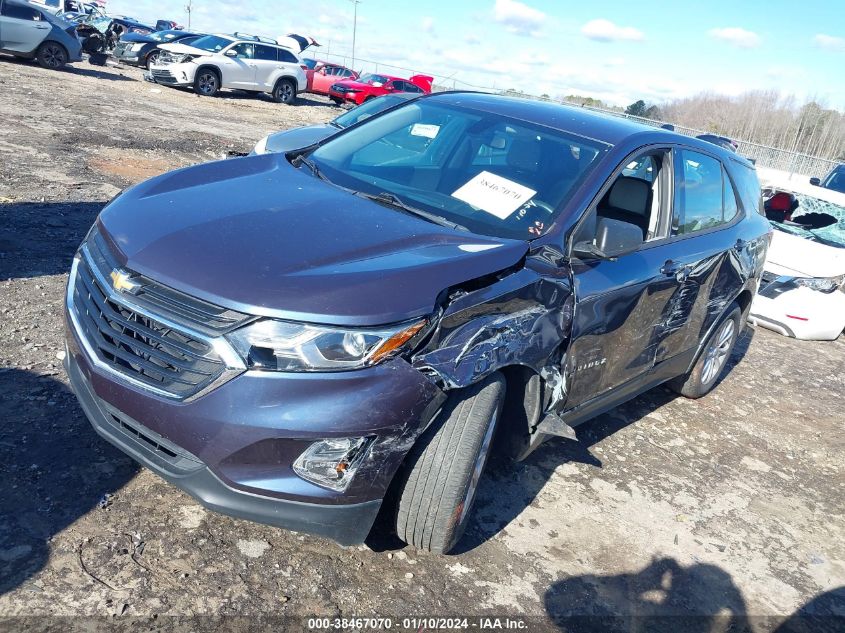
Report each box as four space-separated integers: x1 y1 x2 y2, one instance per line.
227 319 427 371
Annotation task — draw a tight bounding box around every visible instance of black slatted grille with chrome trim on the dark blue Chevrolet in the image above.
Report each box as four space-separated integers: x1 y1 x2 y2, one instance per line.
69 233 249 399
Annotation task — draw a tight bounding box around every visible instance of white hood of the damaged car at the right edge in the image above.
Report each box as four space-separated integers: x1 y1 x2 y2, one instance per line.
766 231 845 277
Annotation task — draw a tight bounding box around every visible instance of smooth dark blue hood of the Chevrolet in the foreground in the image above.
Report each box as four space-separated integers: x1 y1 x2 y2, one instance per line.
98 154 528 326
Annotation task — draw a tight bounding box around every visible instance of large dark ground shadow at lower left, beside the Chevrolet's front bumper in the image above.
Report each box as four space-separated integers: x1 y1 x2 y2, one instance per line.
0 369 139 594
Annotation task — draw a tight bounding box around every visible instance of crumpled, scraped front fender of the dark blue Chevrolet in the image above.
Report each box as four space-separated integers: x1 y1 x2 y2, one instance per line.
411 247 575 458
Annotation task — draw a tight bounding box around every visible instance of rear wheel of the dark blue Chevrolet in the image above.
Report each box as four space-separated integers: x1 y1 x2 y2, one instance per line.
667 304 742 399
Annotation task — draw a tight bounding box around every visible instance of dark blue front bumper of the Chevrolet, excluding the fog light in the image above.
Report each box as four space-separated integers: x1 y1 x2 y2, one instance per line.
65 302 445 544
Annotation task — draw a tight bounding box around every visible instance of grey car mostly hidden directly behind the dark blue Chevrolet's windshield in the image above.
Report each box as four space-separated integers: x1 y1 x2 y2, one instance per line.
252 92 419 155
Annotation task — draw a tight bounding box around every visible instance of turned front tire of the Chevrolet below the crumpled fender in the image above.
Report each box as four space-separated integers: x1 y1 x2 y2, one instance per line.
396 372 506 554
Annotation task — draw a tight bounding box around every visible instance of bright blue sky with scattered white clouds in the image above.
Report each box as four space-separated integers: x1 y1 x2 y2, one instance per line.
108 0 845 110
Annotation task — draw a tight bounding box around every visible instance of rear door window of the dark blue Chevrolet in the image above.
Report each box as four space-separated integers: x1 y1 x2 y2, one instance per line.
672 149 724 235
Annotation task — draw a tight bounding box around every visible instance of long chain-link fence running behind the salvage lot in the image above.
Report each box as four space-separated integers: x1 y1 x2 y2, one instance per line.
308 50 837 178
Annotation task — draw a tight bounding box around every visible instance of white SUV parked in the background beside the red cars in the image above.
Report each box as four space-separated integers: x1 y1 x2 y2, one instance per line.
145 33 308 104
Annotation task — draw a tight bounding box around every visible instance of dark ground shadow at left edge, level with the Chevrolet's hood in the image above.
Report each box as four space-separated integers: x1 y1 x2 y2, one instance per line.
0 202 105 280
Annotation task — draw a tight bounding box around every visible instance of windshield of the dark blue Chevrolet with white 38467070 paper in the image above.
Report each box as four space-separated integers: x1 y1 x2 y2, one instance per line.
310 99 608 240
